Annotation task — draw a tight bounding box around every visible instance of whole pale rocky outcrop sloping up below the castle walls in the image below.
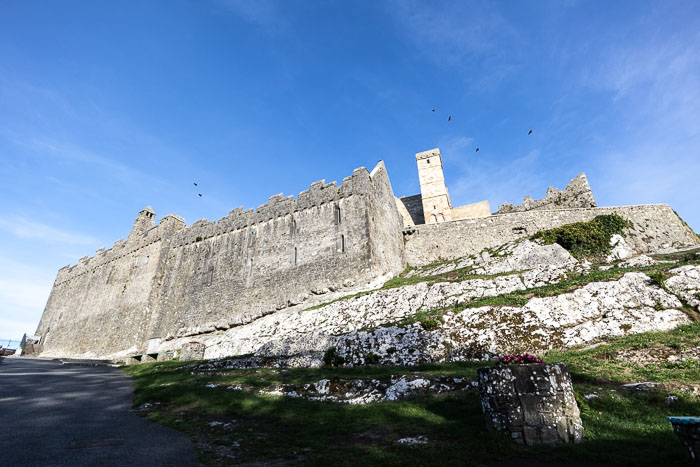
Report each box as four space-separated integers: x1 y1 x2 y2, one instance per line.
159 239 700 368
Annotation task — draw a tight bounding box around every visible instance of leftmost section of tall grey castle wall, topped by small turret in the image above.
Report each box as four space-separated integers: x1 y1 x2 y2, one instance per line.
36 215 185 355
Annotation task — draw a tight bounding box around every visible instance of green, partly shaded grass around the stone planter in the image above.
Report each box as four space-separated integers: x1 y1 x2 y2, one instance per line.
125 323 700 466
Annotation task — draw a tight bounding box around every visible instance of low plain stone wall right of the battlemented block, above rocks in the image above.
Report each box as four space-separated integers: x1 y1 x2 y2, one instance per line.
404 204 700 266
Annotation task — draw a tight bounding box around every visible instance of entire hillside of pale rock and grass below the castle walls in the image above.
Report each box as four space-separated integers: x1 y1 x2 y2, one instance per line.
125 218 700 466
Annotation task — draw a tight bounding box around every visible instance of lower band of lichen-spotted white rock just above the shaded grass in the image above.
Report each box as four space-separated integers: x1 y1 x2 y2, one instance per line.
324 273 691 365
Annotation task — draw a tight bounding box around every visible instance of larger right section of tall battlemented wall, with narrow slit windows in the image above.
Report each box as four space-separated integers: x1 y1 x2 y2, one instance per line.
151 163 403 338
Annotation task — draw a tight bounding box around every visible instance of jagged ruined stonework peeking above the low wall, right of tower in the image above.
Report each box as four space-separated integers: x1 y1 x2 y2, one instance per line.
496 173 597 214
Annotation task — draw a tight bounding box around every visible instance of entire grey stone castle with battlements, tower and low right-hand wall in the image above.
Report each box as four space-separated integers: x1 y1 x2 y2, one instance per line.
35 149 698 361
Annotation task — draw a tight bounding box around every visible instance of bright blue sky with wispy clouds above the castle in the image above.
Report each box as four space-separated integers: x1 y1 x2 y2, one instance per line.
0 0 700 339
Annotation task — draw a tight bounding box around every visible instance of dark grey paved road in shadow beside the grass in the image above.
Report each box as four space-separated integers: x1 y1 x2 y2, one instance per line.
0 357 199 466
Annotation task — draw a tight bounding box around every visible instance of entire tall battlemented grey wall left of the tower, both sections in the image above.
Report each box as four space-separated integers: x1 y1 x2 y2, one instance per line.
37 163 404 356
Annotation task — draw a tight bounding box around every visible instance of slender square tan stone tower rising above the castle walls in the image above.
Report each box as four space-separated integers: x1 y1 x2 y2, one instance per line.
416 148 452 224
